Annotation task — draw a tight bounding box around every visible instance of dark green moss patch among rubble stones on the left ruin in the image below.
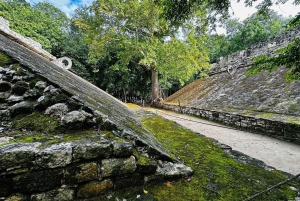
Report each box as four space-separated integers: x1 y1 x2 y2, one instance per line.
12 112 60 133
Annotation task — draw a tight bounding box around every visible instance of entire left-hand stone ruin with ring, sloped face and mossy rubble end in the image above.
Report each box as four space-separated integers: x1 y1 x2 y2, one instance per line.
0 18 192 201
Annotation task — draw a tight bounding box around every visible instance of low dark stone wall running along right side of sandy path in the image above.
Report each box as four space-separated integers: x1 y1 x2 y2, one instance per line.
156 103 300 144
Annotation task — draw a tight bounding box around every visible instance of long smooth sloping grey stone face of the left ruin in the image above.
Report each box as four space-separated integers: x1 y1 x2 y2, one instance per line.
0 32 171 159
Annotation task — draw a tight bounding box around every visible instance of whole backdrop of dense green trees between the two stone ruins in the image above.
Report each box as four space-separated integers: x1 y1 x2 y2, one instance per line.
0 0 299 101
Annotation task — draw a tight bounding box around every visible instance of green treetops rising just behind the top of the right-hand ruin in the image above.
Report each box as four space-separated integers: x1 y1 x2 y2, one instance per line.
206 11 289 62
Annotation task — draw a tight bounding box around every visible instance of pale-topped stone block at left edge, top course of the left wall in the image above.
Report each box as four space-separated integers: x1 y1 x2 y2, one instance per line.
0 143 41 170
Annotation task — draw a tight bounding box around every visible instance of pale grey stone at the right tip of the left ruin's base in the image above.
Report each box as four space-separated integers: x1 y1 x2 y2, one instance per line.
156 162 193 178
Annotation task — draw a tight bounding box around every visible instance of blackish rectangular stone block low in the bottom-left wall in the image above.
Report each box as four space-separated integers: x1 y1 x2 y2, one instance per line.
13 169 63 193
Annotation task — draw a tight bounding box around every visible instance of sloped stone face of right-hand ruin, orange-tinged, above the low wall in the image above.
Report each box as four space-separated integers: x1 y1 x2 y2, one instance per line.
164 26 300 117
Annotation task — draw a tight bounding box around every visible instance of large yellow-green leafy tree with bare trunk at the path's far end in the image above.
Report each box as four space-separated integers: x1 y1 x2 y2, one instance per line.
77 0 209 101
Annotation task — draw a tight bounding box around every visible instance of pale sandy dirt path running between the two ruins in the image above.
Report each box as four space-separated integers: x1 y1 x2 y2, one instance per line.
146 108 300 175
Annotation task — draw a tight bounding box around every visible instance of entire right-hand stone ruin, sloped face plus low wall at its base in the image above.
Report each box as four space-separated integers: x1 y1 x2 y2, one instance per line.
162 26 300 144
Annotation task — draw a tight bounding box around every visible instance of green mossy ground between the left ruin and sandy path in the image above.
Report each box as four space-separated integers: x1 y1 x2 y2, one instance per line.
102 117 300 201
